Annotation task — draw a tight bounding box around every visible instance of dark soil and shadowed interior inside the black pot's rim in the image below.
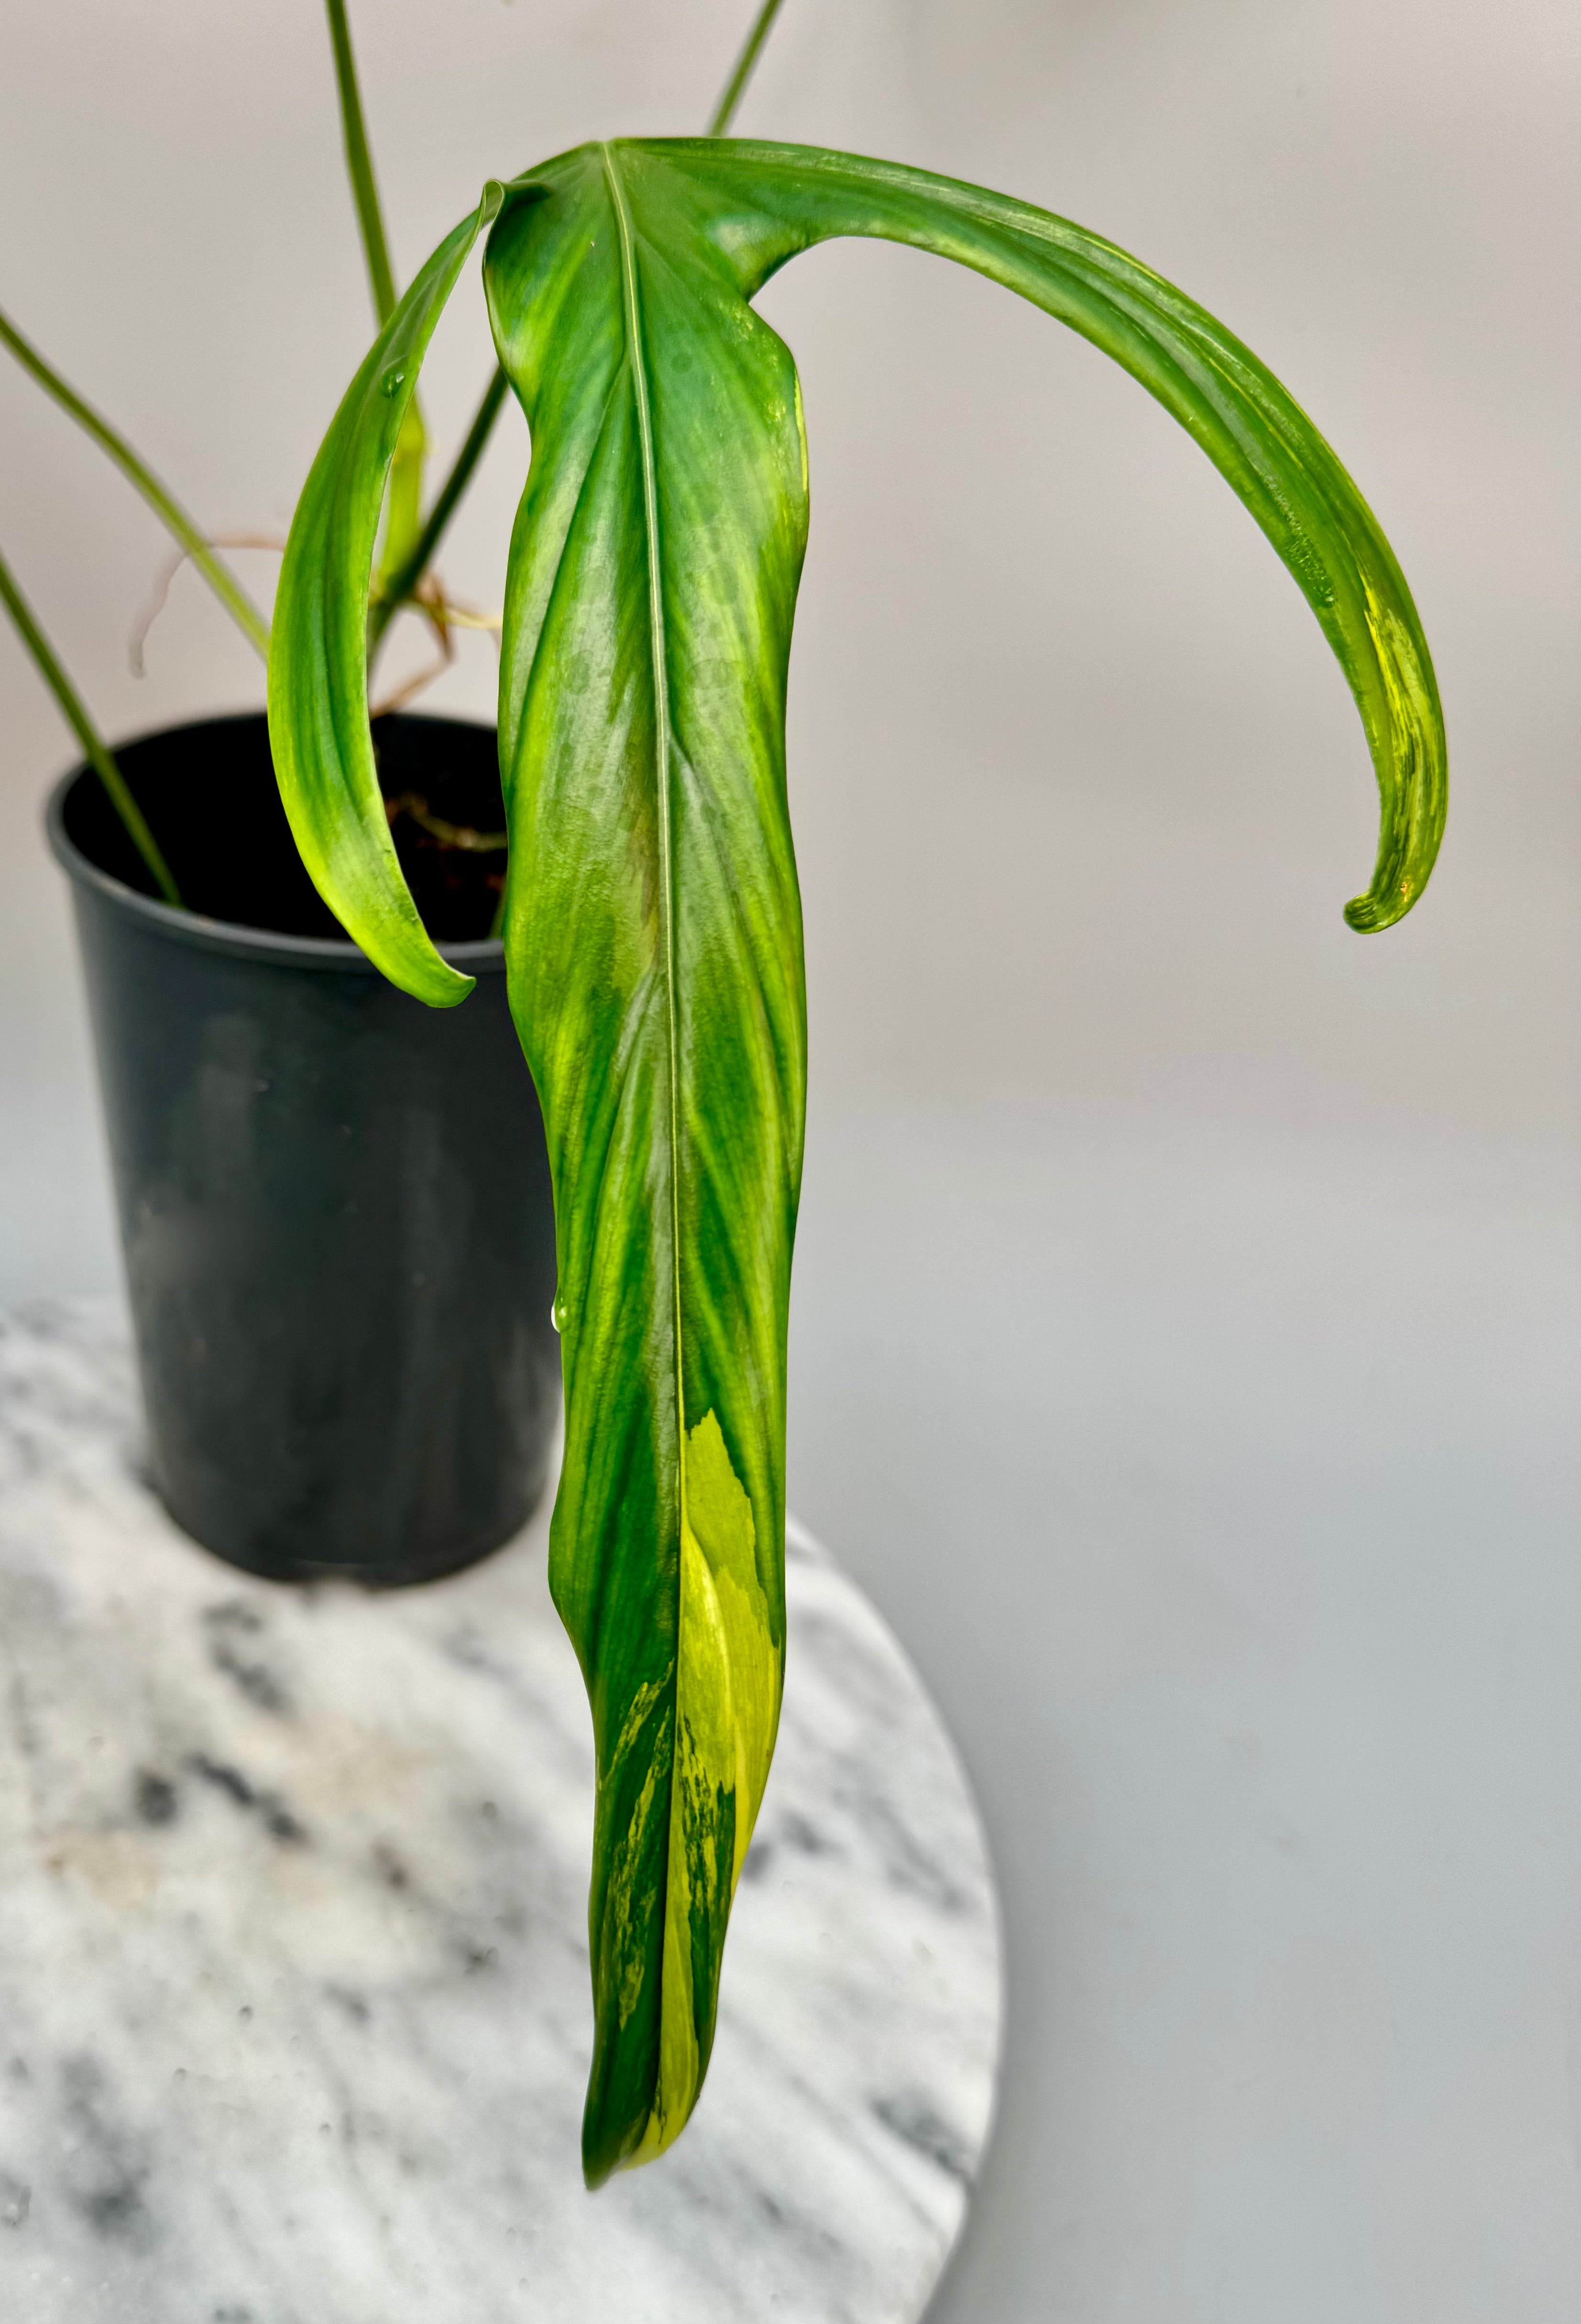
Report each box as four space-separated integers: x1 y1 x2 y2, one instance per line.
65 711 505 944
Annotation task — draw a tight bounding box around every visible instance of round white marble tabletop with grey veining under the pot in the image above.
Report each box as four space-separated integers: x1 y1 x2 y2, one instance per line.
0 1304 1000 2324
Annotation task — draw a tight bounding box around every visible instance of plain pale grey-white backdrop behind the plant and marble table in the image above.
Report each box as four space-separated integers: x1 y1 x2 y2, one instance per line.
0 0 1581 2324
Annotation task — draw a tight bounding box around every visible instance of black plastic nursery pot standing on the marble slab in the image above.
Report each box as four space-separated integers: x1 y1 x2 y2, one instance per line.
49 716 560 1585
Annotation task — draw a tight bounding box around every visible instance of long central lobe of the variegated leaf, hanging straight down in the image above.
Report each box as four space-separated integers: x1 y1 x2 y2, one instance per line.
483 146 807 2180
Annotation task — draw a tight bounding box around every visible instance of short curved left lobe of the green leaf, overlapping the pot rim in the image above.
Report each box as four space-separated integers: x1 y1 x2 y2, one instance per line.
270 184 505 1009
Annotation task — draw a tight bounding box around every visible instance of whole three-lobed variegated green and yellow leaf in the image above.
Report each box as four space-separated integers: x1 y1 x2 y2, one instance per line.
270 140 1446 2184
